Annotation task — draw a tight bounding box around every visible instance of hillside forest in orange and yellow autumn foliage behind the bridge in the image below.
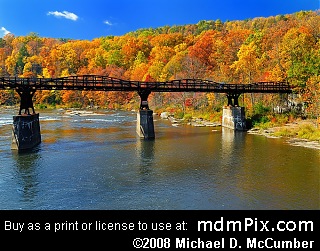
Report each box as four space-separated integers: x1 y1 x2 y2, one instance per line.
0 11 320 116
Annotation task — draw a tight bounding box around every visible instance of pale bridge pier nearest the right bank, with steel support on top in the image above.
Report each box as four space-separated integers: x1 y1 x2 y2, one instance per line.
222 93 247 131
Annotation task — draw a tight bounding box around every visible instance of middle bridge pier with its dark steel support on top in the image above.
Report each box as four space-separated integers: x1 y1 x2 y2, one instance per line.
136 90 155 139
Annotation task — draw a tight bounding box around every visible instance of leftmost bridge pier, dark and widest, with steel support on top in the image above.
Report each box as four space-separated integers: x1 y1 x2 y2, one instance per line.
11 88 41 150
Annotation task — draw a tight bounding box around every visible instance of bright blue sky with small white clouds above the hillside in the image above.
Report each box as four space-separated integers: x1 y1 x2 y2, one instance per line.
0 0 320 40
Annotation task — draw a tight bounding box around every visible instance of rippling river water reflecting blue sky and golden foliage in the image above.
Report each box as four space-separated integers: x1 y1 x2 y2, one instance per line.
0 109 320 210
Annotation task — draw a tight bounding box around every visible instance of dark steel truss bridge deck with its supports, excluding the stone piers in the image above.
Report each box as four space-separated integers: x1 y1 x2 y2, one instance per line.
0 75 292 114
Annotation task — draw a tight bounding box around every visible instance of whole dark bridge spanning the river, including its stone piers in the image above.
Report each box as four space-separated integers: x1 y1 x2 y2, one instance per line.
0 75 292 151
